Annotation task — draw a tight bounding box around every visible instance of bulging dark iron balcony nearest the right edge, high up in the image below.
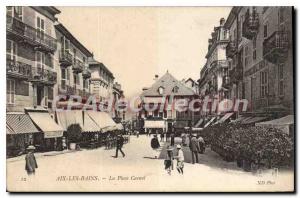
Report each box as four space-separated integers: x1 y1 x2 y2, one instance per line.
263 31 289 64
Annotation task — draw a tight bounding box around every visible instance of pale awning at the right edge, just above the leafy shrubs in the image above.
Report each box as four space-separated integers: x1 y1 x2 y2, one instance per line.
255 115 294 133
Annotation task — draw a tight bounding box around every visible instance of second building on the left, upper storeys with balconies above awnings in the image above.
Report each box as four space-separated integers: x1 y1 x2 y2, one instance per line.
55 24 93 105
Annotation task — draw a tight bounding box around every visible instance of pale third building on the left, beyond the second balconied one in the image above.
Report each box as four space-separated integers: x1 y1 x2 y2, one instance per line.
88 57 114 103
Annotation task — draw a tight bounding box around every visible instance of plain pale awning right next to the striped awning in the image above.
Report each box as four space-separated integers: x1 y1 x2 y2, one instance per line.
28 112 64 138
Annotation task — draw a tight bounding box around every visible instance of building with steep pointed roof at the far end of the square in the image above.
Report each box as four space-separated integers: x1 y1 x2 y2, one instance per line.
138 72 199 135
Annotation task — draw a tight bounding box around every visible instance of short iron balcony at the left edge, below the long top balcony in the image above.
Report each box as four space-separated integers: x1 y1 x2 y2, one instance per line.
6 59 31 80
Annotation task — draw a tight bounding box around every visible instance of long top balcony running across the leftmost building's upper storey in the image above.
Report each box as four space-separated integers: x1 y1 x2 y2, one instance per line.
6 15 57 53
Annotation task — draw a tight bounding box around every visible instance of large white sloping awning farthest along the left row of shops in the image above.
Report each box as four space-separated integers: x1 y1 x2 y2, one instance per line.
86 111 116 132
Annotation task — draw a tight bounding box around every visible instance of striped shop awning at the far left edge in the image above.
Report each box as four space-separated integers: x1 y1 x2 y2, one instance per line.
6 113 40 135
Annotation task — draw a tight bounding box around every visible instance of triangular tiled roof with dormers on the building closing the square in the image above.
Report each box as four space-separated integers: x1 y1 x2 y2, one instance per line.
141 72 196 96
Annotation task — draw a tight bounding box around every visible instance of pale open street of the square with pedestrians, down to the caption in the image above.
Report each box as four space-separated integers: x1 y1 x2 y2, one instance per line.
7 135 294 192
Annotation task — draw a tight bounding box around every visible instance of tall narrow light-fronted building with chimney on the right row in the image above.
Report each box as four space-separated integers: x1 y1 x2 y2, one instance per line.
198 18 229 110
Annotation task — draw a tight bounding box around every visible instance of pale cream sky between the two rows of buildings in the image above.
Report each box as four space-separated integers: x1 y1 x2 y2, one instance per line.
58 7 231 98
